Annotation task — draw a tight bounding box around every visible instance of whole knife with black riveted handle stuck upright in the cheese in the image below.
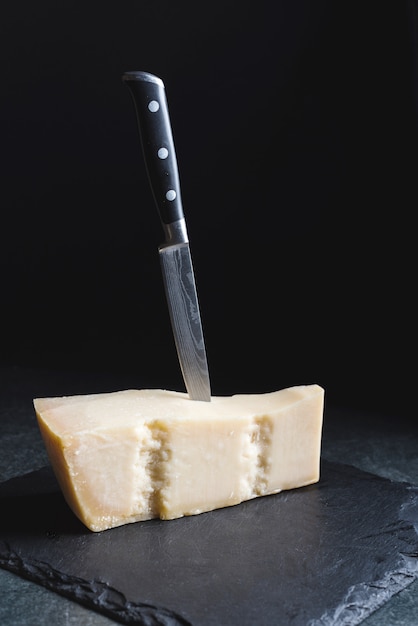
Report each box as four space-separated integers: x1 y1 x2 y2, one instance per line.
122 72 211 402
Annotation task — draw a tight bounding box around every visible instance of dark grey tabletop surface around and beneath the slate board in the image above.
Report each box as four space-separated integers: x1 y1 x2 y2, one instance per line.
0 368 418 626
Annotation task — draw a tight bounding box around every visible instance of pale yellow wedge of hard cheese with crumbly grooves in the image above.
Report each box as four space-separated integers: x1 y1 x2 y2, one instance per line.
34 385 324 531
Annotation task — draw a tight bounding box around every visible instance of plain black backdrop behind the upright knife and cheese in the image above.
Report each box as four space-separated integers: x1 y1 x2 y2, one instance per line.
0 0 418 415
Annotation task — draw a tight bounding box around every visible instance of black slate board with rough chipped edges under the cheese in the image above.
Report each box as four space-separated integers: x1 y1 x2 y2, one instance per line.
0 461 418 626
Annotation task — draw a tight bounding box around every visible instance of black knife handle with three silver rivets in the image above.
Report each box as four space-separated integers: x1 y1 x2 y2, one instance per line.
122 72 184 225
